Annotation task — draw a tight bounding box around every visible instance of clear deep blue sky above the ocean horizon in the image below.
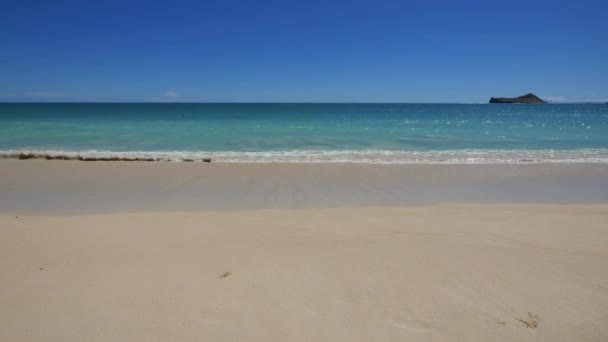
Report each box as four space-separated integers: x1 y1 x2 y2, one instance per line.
0 0 608 103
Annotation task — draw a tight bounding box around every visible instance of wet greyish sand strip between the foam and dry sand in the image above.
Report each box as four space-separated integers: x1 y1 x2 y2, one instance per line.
0 159 608 214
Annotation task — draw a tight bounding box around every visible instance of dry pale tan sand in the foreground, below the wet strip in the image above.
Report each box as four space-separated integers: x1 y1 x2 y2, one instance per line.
0 203 608 341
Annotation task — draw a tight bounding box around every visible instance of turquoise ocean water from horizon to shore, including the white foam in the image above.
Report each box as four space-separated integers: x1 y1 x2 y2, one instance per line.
0 103 608 164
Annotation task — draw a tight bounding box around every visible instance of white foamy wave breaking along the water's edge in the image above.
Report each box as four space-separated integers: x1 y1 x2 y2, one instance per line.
0 149 608 164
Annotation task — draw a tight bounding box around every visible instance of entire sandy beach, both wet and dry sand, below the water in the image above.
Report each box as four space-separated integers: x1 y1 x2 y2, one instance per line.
0 160 608 341
